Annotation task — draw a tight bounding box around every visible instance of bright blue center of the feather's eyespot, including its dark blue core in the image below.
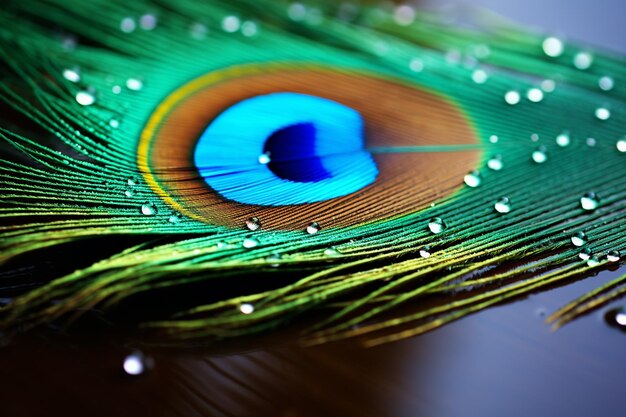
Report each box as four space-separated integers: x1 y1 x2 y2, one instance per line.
193 93 378 206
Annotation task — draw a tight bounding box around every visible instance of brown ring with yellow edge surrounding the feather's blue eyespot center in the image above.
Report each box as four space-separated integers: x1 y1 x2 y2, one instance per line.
137 63 480 230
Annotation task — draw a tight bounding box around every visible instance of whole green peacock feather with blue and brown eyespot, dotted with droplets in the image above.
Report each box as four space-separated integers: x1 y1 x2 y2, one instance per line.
0 0 626 344
